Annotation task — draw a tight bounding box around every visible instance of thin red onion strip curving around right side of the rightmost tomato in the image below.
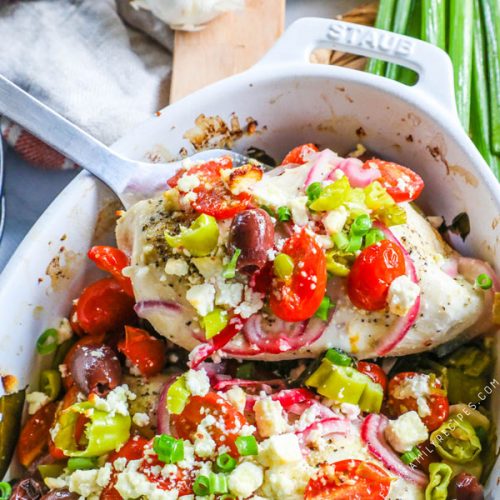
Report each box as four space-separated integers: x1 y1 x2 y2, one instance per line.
373 222 420 356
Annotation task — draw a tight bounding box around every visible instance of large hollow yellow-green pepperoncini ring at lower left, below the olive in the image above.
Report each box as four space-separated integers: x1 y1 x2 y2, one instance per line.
54 402 131 457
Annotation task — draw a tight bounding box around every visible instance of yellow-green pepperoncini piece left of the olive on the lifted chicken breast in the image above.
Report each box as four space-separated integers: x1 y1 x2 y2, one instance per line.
165 214 219 257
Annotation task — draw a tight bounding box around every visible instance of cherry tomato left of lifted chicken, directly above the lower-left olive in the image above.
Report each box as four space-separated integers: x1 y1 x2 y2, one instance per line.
75 278 135 335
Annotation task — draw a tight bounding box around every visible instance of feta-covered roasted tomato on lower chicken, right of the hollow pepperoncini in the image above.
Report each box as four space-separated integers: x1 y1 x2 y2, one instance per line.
171 392 247 457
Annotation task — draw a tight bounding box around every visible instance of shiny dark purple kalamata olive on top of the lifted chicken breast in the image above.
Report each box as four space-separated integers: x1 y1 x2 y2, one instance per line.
229 208 274 274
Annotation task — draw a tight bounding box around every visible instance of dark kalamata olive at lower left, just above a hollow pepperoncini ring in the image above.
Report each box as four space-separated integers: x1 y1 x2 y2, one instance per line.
70 344 122 396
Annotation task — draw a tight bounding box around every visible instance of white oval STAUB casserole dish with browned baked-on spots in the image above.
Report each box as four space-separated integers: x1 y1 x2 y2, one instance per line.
0 19 500 498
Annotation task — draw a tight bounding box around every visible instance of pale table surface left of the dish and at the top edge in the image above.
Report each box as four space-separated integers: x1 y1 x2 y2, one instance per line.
0 0 366 270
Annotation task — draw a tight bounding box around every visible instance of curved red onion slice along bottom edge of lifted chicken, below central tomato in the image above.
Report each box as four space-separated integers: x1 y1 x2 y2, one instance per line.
243 313 326 354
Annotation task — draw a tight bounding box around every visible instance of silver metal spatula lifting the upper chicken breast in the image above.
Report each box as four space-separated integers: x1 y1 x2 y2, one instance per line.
0 75 266 208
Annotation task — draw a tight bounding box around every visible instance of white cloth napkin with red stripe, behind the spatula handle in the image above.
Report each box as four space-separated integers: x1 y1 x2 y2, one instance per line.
0 0 173 169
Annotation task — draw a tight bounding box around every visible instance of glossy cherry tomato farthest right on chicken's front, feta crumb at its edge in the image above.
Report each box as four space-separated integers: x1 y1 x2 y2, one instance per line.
347 240 406 311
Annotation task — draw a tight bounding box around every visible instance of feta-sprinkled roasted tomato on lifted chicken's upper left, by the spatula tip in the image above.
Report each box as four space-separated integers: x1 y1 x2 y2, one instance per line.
167 157 252 219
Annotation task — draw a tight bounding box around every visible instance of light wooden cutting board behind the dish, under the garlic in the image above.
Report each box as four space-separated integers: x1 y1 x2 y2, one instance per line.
170 0 285 102
